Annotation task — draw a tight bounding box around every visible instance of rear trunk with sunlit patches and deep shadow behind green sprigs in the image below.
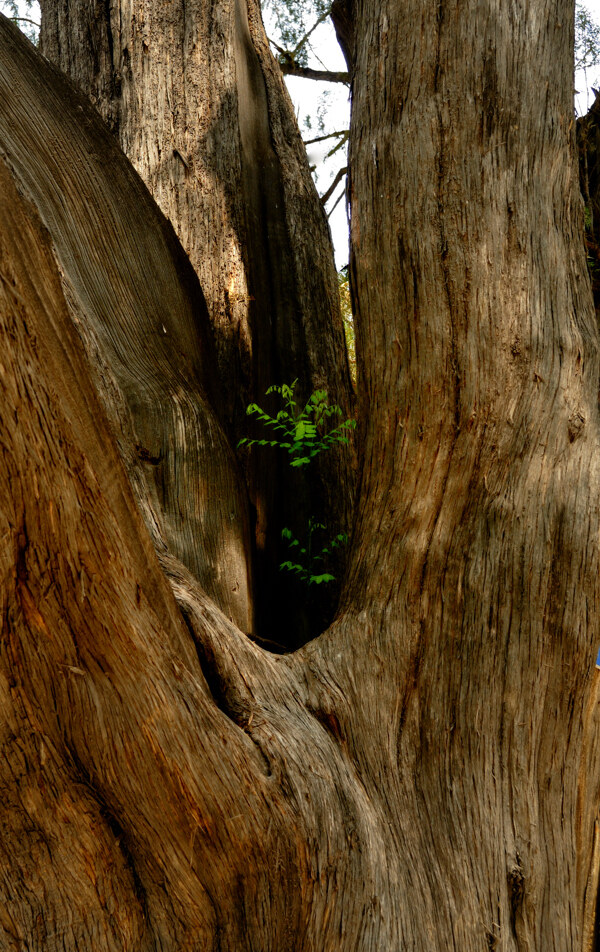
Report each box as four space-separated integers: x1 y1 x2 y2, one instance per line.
40 0 354 646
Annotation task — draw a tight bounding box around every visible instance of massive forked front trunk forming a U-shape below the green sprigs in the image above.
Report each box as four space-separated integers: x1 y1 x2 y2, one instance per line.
0 0 600 952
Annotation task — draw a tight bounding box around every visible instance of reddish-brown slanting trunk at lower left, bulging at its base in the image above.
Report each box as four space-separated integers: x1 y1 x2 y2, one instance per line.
0 147 404 952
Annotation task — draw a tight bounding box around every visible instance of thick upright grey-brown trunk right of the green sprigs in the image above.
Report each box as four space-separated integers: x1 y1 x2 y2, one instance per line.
337 0 600 952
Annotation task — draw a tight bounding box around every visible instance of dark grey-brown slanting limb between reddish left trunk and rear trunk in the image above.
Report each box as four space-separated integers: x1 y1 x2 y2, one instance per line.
0 16 253 632
